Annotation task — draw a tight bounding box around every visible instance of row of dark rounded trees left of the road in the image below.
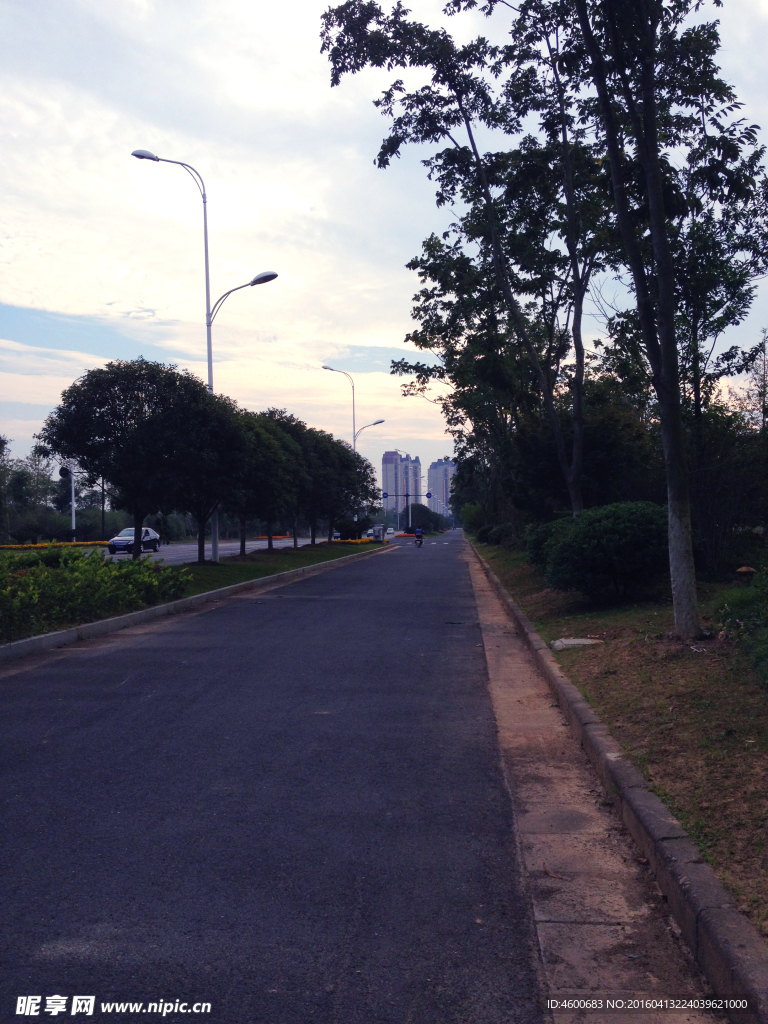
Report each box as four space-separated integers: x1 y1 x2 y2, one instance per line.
0 358 379 560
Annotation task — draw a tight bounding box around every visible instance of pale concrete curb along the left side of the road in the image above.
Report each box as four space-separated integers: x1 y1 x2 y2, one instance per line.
0 547 395 665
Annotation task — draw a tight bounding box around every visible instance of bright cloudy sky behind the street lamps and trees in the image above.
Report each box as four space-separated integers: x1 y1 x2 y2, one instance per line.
0 0 768 481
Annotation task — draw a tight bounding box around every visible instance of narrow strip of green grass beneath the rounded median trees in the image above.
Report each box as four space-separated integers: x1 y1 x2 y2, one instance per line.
179 541 384 597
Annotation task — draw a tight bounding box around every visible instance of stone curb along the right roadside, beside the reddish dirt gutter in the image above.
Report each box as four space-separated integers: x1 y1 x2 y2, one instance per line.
470 545 768 1024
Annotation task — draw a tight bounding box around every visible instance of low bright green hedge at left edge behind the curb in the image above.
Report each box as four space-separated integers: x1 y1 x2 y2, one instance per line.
0 548 186 643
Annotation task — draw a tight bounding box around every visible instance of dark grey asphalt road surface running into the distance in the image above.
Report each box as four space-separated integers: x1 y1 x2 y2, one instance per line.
0 531 543 1024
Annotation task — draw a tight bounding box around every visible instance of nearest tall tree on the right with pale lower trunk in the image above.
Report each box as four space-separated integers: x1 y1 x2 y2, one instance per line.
571 0 768 637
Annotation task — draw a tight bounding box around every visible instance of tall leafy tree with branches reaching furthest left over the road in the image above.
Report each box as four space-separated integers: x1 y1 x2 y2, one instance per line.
323 0 610 514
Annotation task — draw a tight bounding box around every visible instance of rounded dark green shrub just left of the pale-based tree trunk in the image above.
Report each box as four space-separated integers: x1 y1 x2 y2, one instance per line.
543 502 669 597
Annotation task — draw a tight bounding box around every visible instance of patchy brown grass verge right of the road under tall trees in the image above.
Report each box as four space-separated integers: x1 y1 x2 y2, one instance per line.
475 544 768 936
